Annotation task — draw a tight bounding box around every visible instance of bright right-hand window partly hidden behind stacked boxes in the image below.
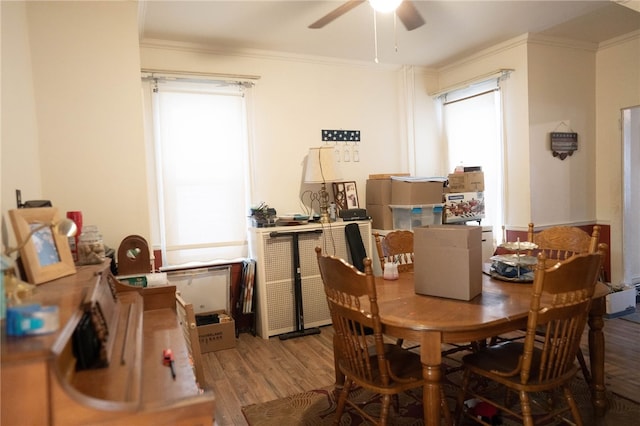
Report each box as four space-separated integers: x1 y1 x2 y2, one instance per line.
442 79 504 244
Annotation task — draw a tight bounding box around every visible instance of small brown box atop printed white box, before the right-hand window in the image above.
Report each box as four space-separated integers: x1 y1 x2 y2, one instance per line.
444 168 485 223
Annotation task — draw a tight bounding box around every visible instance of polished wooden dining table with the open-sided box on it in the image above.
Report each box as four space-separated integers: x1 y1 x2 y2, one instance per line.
364 272 608 425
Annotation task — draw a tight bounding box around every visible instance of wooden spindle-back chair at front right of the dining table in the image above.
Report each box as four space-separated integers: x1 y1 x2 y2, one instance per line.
456 244 606 426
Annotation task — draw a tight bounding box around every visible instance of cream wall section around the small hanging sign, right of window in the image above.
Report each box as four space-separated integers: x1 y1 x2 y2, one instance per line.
528 38 597 227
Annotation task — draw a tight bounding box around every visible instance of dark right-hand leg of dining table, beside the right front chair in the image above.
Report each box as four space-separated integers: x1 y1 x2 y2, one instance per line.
589 297 607 417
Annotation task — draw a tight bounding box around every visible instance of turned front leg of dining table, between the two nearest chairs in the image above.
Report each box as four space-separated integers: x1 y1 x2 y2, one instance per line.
420 332 451 426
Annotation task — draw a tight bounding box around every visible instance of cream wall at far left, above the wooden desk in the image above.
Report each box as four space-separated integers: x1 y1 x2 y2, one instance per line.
2 2 149 248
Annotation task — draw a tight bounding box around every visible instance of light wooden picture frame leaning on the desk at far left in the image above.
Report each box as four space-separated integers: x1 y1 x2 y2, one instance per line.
9 207 76 284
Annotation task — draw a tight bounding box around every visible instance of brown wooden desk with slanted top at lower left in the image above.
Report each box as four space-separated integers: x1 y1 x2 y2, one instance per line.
0 262 215 426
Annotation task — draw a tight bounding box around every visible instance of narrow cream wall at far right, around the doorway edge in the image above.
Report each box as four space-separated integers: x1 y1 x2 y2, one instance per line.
594 32 640 284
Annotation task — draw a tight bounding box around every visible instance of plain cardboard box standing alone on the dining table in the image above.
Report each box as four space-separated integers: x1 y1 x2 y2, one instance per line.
413 225 482 300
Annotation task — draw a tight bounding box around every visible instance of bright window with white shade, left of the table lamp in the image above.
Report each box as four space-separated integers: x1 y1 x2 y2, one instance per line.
143 76 251 266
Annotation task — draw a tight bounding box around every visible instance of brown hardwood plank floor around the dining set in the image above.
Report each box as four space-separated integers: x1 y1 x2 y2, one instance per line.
203 305 640 426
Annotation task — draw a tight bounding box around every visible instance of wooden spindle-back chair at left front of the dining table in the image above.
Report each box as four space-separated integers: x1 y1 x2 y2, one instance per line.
316 247 451 425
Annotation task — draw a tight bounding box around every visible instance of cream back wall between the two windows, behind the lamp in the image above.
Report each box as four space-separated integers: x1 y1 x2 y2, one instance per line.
140 42 416 212
